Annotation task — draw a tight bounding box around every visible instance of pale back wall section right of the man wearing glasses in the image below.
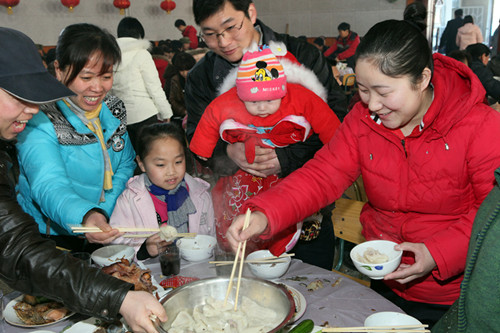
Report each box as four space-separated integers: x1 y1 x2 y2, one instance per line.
254 0 406 37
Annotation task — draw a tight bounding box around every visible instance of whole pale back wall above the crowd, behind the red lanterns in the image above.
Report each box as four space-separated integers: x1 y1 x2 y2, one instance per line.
0 0 406 45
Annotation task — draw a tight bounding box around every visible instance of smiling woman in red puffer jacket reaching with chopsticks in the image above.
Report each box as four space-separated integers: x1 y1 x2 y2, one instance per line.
228 16 500 325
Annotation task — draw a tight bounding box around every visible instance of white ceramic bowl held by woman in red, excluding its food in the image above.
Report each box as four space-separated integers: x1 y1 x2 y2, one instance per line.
351 240 403 280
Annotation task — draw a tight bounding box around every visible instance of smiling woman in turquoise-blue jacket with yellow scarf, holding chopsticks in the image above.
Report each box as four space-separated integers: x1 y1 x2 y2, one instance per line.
17 24 136 251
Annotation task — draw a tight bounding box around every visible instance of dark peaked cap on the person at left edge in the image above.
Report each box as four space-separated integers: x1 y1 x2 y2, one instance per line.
0 27 75 104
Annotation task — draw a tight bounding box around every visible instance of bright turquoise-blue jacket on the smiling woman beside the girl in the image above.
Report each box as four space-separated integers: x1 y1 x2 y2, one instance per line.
17 97 136 235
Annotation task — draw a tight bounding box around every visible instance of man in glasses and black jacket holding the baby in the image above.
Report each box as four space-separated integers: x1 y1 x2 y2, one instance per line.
185 0 347 268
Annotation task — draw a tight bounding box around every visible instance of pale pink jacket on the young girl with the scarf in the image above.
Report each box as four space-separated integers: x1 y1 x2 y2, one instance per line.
109 173 215 254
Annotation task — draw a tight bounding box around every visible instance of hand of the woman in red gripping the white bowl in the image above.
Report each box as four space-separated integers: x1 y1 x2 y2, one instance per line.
384 242 436 284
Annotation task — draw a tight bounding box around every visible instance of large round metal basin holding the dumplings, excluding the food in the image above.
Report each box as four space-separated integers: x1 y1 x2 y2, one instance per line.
161 277 295 332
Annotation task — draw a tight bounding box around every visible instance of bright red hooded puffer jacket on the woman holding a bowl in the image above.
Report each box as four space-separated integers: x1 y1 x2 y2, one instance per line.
242 54 500 304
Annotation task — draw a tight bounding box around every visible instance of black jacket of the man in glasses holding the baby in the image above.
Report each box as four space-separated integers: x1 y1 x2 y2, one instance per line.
185 20 347 177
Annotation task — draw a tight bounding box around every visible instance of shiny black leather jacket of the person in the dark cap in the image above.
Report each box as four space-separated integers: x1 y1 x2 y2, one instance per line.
0 140 133 320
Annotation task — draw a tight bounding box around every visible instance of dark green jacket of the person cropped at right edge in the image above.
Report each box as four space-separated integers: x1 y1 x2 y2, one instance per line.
432 168 500 333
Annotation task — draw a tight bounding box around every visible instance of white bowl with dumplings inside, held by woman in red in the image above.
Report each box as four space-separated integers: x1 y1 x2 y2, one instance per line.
351 240 403 280
